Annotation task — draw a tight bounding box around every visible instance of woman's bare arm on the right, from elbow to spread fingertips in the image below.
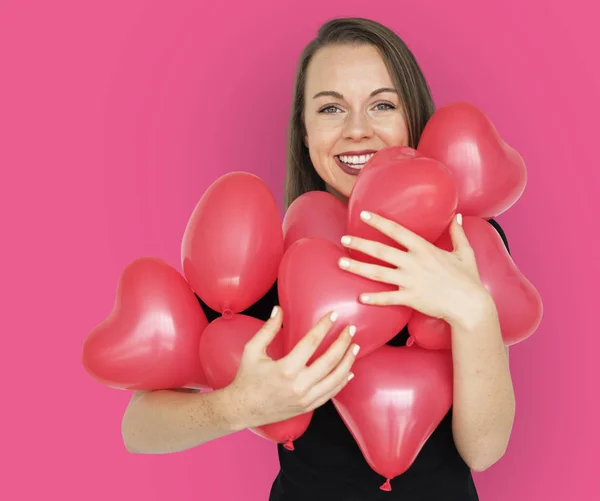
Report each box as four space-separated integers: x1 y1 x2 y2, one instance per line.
339 213 515 471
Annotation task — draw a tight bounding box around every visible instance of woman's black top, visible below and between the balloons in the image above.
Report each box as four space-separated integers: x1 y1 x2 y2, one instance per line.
200 220 508 501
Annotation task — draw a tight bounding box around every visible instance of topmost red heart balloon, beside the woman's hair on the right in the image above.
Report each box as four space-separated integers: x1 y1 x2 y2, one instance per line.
417 102 527 219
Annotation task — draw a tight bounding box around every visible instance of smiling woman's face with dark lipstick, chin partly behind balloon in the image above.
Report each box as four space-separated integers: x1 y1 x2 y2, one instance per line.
304 45 408 200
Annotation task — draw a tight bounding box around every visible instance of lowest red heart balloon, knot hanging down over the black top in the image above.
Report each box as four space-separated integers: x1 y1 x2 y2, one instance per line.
333 346 453 491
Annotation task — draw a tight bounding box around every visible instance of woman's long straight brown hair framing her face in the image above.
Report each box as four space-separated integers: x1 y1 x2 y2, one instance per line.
285 18 435 209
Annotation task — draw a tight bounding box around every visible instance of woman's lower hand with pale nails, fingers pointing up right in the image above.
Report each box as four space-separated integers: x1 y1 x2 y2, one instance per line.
224 307 359 428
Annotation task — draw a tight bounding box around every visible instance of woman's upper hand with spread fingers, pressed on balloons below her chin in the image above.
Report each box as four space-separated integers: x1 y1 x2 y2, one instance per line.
339 212 493 325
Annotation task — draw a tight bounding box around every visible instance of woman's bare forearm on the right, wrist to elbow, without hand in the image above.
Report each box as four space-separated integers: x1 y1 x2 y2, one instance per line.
450 294 515 471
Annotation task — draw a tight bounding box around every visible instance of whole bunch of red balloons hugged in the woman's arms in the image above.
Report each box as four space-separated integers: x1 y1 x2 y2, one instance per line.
83 102 542 490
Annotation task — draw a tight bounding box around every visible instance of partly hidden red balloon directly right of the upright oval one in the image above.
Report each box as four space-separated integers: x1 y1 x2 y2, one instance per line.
283 191 348 250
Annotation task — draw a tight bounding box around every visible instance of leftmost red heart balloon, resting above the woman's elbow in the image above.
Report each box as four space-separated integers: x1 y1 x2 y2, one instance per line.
82 257 208 390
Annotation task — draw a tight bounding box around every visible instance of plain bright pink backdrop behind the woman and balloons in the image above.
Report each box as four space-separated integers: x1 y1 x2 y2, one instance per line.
0 0 600 501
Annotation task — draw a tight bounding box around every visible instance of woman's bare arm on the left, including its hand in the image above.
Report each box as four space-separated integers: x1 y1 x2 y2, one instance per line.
122 307 357 454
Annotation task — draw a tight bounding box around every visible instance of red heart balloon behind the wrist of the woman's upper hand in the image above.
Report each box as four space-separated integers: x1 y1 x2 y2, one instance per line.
408 216 543 350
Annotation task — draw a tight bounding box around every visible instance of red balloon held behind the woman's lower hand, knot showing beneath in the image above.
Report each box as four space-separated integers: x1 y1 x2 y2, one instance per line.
200 314 313 450
